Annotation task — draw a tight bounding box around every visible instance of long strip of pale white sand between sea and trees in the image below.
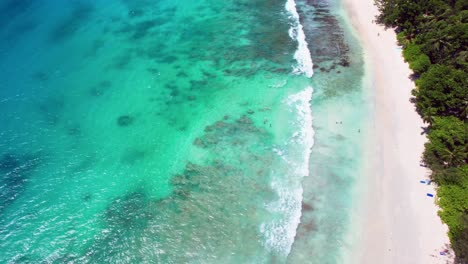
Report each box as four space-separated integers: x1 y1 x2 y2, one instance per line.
344 0 452 264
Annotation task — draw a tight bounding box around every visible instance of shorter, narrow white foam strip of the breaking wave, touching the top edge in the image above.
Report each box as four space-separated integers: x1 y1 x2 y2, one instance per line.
285 0 314 78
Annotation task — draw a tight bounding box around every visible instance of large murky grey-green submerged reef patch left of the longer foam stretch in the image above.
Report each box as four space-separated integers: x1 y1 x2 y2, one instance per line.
77 116 282 263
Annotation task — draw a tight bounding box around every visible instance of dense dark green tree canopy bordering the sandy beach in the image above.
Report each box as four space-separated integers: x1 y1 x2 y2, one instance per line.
375 0 468 263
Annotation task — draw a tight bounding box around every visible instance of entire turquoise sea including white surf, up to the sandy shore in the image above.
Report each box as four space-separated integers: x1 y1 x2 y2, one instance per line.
0 0 367 263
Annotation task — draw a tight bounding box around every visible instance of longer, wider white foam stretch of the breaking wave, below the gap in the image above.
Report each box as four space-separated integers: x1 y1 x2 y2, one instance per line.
260 87 314 256
